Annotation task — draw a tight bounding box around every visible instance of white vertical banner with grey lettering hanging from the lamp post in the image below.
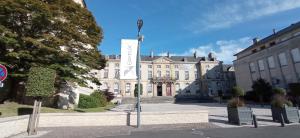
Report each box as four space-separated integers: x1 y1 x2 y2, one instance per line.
120 39 138 79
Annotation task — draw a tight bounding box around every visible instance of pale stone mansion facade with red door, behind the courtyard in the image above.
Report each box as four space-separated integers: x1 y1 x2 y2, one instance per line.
98 52 234 97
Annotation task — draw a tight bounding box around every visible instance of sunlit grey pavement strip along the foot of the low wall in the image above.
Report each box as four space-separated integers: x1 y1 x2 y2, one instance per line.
12 123 218 138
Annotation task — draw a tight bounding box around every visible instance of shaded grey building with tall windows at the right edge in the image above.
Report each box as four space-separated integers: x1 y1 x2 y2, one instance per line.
234 22 300 91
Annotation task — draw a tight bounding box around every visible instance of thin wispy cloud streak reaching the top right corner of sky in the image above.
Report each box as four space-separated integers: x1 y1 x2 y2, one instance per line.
188 0 300 33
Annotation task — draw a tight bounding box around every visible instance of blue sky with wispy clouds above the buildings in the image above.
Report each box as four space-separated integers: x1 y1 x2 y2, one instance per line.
86 0 300 63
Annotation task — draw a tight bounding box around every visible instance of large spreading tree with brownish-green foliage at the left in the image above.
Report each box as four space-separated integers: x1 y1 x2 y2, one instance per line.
0 0 105 101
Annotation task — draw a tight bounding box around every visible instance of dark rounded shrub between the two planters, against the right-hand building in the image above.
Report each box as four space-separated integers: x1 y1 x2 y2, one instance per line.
252 78 272 104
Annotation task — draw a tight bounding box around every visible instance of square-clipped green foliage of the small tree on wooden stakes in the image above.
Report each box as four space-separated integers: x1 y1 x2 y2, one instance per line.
26 67 56 97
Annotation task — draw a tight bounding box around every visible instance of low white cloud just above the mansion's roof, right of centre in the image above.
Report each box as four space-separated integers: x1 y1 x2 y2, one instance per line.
159 37 252 64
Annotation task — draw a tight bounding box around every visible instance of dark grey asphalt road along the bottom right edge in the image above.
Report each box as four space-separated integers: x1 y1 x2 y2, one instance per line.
105 125 300 138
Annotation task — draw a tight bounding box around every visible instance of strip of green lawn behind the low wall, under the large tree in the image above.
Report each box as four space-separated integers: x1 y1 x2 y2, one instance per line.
0 102 115 117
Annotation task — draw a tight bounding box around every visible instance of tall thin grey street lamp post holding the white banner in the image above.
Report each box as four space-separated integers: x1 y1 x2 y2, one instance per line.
137 19 143 128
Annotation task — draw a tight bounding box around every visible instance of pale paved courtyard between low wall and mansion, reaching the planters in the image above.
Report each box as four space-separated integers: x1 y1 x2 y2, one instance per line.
112 103 298 128
